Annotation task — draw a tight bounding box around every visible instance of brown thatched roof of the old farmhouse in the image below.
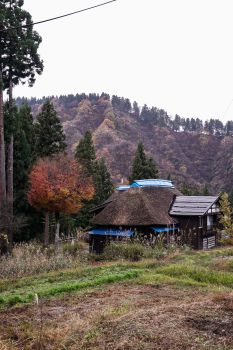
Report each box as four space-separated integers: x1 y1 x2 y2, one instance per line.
92 187 182 226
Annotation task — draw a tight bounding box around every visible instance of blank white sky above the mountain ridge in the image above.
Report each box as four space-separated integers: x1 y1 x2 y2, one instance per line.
15 0 233 121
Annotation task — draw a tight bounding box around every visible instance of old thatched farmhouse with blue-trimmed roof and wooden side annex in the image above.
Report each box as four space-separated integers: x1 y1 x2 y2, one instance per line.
89 179 219 253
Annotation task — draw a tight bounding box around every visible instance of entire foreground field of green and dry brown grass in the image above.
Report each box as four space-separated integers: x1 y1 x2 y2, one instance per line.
0 248 233 350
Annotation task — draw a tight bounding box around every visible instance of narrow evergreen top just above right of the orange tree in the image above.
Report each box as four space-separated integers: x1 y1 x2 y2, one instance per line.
75 131 96 175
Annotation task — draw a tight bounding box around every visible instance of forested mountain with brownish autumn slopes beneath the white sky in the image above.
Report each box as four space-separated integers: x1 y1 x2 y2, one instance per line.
16 93 233 193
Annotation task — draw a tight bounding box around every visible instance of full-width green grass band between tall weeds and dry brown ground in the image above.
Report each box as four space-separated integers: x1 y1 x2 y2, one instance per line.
0 249 233 308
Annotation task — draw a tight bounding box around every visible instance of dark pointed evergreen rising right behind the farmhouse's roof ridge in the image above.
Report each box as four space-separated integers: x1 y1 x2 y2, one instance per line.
129 142 159 182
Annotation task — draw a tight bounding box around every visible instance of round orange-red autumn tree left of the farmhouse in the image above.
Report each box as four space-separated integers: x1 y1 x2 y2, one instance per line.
28 155 94 245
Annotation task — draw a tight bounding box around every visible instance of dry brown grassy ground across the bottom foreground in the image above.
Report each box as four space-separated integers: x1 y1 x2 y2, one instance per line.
0 284 233 350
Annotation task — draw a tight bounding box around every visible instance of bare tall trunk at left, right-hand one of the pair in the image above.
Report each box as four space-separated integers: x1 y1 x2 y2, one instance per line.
7 80 14 246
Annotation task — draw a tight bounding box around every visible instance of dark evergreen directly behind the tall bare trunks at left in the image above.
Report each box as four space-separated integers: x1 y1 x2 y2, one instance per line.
4 102 38 241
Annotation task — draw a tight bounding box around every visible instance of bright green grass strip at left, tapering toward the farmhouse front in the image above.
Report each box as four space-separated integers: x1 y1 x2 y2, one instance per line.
0 265 142 307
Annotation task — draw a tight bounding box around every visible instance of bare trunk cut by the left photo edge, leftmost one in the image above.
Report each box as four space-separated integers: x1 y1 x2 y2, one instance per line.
0 71 6 208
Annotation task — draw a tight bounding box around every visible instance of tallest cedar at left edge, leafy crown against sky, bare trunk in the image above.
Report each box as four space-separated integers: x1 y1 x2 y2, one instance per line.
0 0 43 243
